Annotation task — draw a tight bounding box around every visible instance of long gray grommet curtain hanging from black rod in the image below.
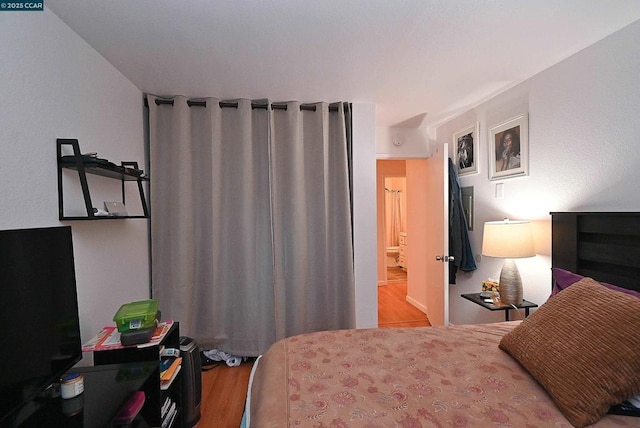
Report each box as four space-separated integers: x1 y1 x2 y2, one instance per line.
147 95 355 356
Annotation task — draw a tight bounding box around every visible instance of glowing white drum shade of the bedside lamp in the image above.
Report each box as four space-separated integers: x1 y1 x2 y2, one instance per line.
482 220 536 259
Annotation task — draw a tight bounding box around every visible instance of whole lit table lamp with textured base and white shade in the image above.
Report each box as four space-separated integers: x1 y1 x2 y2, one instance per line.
482 219 536 305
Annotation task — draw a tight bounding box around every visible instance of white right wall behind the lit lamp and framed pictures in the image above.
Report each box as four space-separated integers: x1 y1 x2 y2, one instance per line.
437 18 640 324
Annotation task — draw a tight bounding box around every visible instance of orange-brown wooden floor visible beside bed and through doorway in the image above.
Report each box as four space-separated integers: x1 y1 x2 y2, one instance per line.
197 268 430 428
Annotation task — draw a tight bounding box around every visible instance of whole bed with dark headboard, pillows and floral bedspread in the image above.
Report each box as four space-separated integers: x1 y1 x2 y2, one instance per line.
243 213 640 428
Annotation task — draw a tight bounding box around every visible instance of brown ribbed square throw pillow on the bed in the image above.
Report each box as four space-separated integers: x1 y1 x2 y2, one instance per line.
500 278 640 427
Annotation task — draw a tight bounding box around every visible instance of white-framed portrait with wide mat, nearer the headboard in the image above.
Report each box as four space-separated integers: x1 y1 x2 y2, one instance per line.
489 114 529 180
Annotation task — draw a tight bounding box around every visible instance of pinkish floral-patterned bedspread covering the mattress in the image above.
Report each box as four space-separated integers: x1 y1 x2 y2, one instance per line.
249 321 640 428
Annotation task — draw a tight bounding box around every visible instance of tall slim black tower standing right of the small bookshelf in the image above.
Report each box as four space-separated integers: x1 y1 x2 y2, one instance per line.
180 336 202 428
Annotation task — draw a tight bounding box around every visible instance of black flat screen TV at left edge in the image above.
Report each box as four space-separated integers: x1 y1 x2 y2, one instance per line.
0 226 82 426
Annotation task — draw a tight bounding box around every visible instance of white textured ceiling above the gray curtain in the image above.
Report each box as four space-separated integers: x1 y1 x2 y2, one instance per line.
45 0 640 127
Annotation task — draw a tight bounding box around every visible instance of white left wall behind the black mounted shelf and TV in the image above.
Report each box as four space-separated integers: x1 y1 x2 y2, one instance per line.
0 8 149 358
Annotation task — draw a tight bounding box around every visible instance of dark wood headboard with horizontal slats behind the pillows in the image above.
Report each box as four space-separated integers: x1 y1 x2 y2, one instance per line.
551 212 640 291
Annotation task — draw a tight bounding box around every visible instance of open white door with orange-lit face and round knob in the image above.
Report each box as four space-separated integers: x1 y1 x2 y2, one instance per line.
407 144 449 326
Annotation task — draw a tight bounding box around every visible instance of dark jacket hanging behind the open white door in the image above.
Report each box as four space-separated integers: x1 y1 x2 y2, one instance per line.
449 159 477 284
